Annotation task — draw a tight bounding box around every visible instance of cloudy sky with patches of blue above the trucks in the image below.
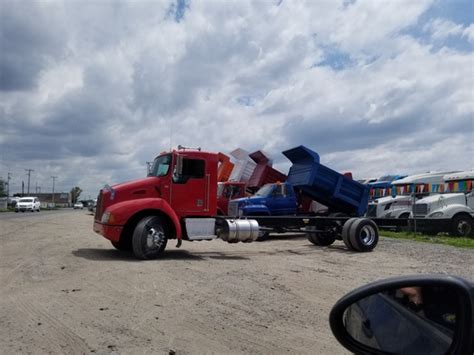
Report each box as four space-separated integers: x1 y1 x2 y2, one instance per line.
0 0 474 198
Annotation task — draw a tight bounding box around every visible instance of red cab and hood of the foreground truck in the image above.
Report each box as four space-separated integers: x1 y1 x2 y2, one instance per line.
94 150 218 258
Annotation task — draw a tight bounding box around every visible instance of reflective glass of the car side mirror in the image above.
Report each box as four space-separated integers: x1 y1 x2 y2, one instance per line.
344 286 459 355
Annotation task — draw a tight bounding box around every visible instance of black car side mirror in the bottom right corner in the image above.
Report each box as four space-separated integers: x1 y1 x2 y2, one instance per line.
329 275 474 355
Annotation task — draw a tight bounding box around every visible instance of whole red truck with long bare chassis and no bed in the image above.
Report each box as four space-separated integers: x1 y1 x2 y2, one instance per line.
93 148 384 259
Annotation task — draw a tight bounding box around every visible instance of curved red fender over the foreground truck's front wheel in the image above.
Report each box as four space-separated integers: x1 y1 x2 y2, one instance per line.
106 198 182 240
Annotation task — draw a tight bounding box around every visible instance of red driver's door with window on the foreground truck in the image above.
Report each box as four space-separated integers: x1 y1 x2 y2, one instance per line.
170 155 210 216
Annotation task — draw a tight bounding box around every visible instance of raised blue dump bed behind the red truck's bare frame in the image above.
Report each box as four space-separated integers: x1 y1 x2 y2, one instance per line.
283 145 369 216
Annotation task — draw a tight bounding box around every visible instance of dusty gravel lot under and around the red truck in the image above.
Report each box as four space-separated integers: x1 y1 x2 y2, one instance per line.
0 211 474 354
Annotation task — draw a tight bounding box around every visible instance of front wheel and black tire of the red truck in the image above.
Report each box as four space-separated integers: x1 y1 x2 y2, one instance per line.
132 216 168 260
